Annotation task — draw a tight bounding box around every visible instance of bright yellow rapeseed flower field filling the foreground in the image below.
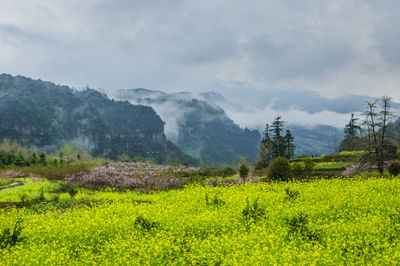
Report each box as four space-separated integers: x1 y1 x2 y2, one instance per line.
0 178 400 265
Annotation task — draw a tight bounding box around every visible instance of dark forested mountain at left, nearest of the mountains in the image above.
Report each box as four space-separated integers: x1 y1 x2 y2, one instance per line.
0 74 196 163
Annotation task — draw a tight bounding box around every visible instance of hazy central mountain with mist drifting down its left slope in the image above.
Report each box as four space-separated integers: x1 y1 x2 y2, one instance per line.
116 89 260 165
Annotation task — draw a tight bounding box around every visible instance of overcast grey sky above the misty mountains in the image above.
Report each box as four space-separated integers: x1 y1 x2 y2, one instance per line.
0 0 400 104
